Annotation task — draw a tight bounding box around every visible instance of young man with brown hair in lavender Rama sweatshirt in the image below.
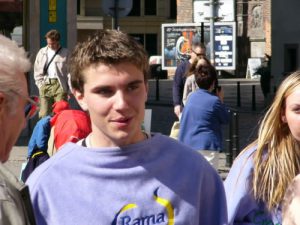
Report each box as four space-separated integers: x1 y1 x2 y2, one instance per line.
28 30 227 225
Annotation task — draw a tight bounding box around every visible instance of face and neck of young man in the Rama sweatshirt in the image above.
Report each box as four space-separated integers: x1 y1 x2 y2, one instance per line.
75 63 148 147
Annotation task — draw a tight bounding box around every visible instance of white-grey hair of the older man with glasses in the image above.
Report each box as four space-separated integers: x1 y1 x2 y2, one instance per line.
0 35 31 109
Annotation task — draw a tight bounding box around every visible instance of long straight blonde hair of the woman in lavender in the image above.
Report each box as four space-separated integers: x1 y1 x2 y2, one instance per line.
252 71 300 210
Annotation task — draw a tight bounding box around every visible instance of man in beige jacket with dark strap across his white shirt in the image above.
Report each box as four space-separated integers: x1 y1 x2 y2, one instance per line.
34 30 69 118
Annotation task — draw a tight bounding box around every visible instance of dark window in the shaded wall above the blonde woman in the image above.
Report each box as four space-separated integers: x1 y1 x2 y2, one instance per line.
284 44 298 73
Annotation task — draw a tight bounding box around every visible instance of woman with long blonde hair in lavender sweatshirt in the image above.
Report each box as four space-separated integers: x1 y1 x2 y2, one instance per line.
225 71 300 224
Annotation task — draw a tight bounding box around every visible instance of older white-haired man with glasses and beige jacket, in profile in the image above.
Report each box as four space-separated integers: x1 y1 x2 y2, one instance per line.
0 35 37 225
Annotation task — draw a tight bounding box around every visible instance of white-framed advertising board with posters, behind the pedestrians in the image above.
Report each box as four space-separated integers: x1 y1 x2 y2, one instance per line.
162 22 235 70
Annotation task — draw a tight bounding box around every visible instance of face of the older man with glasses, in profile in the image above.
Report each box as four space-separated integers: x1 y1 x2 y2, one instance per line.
0 74 28 162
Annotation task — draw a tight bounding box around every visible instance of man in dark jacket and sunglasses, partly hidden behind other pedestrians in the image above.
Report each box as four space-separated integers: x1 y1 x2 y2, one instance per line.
172 42 205 118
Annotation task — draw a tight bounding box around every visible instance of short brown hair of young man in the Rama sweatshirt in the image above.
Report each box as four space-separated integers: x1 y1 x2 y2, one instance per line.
69 30 149 93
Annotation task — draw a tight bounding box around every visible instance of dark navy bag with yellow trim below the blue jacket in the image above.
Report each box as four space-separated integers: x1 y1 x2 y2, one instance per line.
21 151 49 183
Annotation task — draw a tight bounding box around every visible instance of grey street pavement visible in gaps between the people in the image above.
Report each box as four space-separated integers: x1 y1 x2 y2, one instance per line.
6 79 266 179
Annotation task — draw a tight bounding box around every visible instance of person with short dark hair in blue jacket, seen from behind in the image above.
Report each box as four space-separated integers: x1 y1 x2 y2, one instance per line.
179 64 229 166
